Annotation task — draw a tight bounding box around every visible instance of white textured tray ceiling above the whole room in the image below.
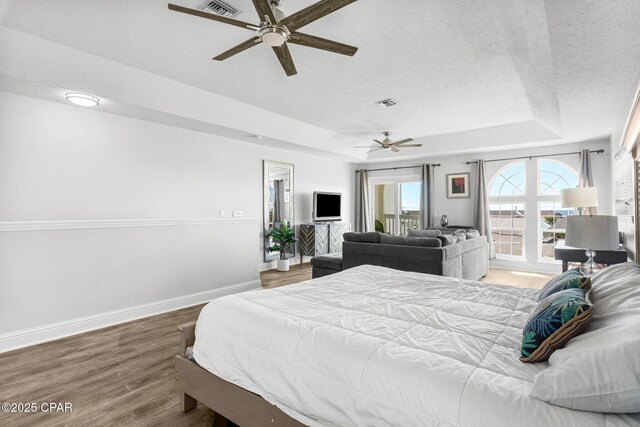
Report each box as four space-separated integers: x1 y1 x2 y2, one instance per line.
0 0 640 161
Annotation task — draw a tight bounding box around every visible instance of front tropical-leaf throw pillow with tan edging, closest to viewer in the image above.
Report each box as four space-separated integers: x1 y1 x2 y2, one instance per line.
520 288 593 362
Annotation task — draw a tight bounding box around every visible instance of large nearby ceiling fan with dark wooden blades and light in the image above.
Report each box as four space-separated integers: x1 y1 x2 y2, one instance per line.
169 0 358 76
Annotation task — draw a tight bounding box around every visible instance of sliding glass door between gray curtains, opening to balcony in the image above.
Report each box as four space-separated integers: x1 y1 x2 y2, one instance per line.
373 180 422 236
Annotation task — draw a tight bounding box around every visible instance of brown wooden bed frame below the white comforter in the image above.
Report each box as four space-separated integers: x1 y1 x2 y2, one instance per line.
175 322 304 427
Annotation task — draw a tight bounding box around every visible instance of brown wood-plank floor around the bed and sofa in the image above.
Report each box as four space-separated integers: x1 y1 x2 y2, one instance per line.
0 264 548 427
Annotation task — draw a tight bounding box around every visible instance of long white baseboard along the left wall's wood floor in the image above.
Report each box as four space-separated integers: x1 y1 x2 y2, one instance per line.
0 280 260 353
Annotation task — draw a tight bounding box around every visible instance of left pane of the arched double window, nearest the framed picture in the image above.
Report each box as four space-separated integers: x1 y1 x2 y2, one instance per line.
489 161 527 259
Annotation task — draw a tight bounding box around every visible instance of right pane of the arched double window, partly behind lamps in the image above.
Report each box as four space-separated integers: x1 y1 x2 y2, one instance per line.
538 159 578 261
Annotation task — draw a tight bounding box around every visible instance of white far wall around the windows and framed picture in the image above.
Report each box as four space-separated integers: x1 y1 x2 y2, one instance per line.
358 140 612 271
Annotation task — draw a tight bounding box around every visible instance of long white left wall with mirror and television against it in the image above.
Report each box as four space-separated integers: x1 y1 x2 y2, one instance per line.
0 92 354 351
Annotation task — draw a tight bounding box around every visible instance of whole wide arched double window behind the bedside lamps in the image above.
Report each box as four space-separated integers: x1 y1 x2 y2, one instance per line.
489 159 578 263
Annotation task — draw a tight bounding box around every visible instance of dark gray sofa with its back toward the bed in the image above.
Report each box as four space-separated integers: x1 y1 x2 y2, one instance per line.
340 229 489 280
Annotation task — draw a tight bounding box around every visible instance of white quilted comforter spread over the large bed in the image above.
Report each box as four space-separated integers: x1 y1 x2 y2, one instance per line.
194 266 640 427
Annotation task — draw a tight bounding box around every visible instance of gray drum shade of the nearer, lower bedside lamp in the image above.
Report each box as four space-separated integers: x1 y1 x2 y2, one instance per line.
565 215 619 250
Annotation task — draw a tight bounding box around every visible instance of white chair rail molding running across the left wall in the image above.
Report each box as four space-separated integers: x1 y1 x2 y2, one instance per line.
0 217 262 232
